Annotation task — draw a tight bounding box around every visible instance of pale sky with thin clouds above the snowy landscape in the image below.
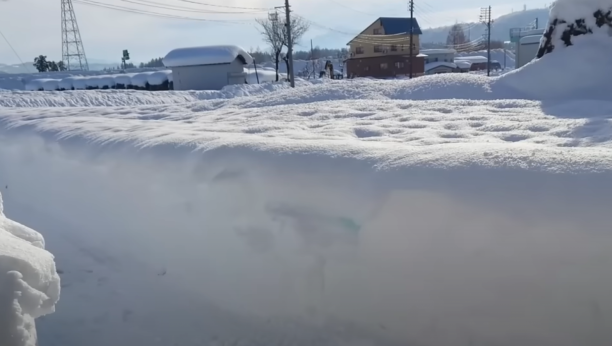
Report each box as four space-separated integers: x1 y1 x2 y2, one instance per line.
0 0 552 64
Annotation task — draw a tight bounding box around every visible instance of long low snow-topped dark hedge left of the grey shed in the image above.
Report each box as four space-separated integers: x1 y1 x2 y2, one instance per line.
25 70 173 91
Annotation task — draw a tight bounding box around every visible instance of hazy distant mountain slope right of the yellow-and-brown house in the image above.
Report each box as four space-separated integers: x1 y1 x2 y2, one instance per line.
417 8 550 43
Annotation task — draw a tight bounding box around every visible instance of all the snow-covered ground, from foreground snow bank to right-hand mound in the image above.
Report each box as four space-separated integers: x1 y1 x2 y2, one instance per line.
0 1 612 346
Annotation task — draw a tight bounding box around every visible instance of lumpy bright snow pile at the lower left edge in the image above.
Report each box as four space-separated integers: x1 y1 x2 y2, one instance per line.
0 194 60 346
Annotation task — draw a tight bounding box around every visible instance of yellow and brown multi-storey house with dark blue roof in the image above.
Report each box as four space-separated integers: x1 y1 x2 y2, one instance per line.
346 17 425 78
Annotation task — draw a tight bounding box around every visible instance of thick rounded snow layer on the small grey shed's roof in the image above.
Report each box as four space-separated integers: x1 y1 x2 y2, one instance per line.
164 45 253 67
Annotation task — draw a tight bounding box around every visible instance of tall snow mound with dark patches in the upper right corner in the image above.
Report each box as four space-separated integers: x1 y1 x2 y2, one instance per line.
500 0 612 100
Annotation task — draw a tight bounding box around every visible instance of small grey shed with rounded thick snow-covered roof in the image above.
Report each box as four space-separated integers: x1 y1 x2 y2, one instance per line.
163 45 253 90
